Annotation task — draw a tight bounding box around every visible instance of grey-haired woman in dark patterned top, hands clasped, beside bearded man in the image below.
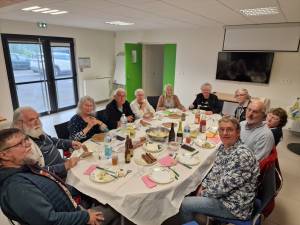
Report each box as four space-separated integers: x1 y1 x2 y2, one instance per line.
68 96 108 142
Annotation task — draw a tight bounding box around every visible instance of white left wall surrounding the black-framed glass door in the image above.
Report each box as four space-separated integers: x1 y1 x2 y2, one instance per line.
0 20 115 119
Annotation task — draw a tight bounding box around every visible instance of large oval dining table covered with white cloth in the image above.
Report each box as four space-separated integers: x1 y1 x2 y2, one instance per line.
67 110 220 225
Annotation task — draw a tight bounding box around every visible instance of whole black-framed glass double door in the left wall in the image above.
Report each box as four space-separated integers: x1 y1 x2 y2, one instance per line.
1 34 78 114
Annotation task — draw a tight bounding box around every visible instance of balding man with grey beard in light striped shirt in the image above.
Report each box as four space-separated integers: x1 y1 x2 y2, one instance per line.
240 100 275 161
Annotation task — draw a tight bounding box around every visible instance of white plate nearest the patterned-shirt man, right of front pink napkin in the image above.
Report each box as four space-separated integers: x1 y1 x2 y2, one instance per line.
149 167 175 184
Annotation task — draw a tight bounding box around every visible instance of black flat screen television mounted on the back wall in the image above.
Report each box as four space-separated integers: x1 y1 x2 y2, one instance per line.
216 52 274 84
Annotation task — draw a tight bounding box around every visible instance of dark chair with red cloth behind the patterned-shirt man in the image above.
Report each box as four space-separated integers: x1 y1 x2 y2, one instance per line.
206 148 282 225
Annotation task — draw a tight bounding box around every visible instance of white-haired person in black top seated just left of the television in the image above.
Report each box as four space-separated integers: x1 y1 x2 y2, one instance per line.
190 83 222 114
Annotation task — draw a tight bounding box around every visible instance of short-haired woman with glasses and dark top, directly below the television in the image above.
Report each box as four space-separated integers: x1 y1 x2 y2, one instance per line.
234 88 251 122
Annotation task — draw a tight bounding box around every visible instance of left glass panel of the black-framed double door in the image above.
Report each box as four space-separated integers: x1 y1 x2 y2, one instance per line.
8 42 50 113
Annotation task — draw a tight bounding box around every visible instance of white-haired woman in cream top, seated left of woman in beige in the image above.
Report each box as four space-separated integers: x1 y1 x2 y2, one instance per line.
130 89 155 119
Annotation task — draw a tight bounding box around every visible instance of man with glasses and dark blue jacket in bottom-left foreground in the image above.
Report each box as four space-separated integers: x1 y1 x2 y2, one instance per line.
0 128 116 225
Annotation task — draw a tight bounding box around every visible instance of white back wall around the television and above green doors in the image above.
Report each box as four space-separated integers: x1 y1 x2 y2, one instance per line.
115 28 300 112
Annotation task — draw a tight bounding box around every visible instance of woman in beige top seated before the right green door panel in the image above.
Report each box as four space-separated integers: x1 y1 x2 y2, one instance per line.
156 84 185 111
